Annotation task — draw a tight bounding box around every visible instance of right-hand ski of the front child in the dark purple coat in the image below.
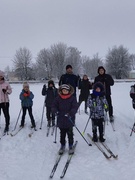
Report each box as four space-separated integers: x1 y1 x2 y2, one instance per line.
60 141 78 179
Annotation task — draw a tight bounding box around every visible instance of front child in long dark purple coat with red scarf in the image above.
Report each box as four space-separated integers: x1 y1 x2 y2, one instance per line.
52 84 78 154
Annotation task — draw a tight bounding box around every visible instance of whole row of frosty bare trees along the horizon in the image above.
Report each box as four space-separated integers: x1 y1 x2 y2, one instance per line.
4 42 135 80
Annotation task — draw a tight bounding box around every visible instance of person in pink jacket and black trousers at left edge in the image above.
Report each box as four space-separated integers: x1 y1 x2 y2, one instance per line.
0 70 12 133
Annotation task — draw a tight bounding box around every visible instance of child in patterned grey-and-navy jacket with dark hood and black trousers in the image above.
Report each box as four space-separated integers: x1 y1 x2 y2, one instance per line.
88 82 108 142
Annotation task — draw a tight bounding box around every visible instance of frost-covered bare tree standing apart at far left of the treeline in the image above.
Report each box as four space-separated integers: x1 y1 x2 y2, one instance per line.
13 47 32 80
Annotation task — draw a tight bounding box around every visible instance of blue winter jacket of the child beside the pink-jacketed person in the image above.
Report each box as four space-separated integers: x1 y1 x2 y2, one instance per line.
20 89 34 107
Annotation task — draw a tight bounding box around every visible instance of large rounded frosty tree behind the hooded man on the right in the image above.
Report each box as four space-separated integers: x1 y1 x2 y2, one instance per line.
106 45 131 79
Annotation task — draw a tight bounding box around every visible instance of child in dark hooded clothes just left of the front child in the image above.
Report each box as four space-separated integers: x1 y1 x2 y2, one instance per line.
42 80 57 127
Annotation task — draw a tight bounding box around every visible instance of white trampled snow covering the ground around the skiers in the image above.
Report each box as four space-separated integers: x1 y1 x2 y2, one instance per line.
0 82 135 180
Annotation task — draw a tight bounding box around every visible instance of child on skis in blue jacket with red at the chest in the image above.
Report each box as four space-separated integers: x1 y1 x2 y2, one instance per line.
20 82 36 130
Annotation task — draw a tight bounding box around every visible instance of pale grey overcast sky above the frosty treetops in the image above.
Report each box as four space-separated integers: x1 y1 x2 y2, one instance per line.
0 0 135 70
